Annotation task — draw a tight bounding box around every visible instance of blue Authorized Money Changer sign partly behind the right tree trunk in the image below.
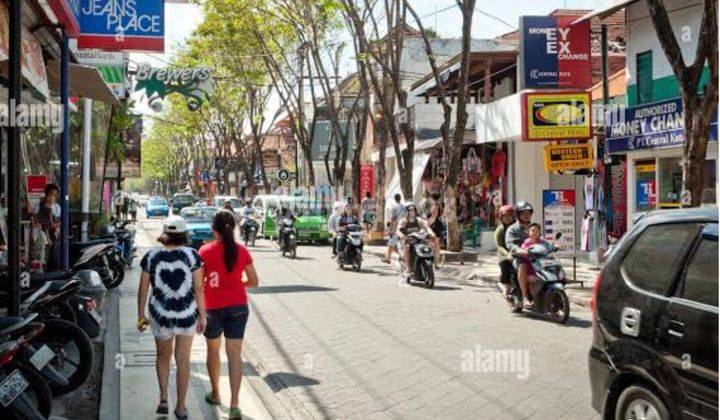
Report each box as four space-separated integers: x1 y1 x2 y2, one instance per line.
605 98 718 153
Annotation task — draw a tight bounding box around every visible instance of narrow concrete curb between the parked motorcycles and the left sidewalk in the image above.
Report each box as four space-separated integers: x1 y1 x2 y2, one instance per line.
98 289 121 420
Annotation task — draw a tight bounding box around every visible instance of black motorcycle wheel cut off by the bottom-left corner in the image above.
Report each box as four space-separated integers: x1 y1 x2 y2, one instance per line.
0 361 52 420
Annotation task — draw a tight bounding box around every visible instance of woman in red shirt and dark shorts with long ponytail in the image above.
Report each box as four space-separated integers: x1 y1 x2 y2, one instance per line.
200 210 258 419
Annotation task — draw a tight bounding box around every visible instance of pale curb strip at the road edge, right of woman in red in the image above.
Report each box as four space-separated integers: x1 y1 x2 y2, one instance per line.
243 341 315 420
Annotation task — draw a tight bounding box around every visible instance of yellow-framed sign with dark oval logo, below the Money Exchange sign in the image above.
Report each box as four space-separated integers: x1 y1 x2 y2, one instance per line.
522 92 592 141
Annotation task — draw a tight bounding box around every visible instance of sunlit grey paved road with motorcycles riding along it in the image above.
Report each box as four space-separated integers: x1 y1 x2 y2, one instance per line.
134 217 598 419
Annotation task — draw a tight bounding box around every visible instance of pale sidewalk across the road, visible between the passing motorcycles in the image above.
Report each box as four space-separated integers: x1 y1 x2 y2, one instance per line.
364 245 599 307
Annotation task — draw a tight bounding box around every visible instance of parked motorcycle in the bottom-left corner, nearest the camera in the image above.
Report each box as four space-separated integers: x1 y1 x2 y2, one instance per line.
0 314 52 420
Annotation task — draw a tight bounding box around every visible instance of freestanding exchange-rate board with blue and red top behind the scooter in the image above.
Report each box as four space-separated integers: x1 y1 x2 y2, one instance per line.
543 190 575 255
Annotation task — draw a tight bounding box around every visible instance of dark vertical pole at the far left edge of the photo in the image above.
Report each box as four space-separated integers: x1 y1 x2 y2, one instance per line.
6 0 23 316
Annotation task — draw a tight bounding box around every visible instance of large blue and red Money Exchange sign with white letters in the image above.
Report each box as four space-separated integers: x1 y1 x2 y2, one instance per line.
519 16 592 89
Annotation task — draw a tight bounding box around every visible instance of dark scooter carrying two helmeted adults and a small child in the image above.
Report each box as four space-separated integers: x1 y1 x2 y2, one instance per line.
507 236 570 324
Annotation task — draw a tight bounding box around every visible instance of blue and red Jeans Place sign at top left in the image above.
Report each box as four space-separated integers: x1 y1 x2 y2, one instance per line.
78 0 165 52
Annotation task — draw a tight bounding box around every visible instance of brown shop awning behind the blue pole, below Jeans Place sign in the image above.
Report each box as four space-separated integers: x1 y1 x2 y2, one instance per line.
47 60 119 104
